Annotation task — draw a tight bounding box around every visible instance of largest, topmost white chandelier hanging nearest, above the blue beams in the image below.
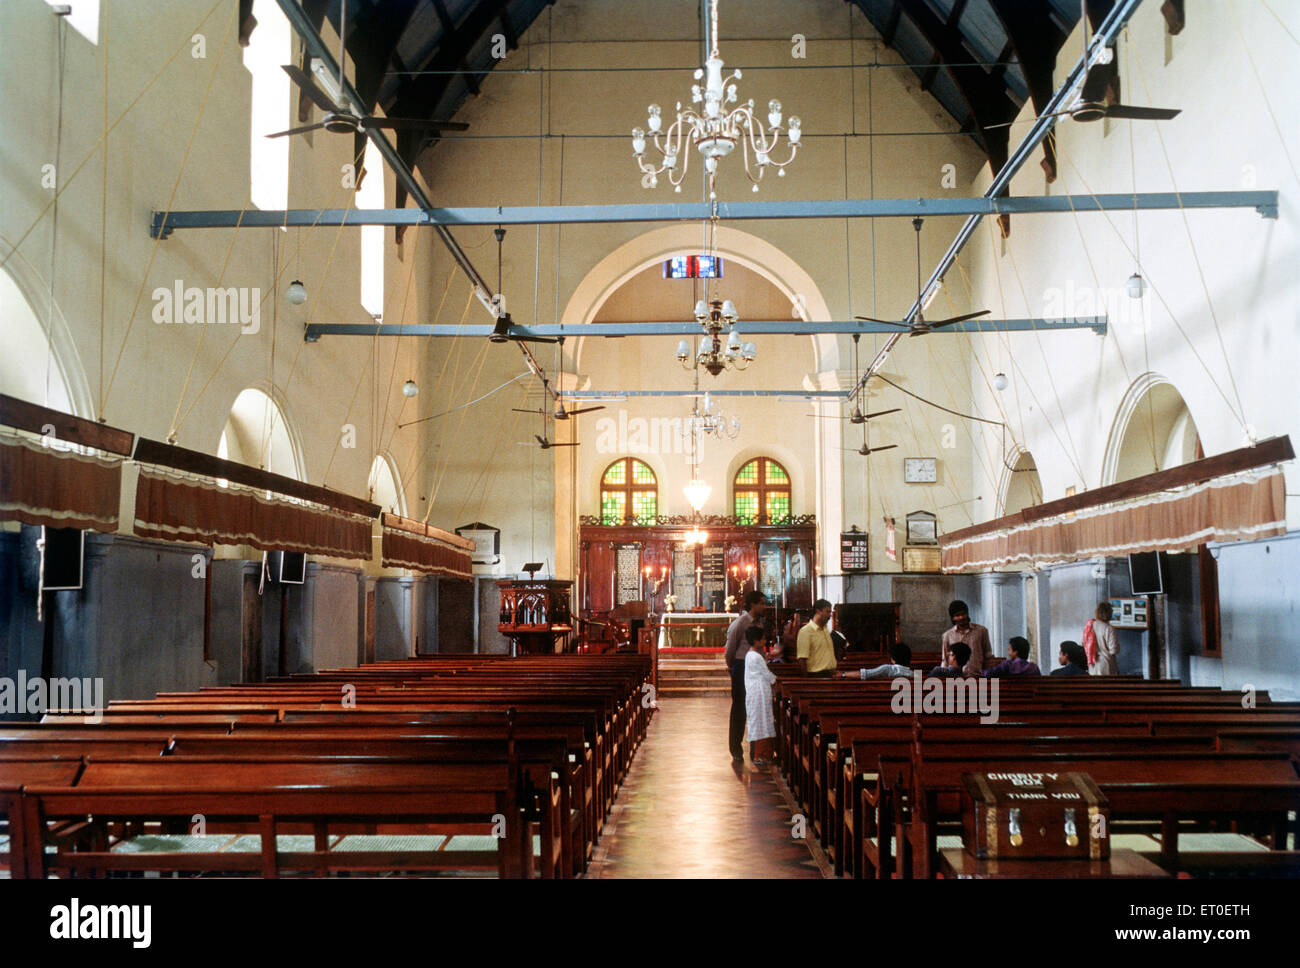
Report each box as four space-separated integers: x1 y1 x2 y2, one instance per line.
632 0 803 199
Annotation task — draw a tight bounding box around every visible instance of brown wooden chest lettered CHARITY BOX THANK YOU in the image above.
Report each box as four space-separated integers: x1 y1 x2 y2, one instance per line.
962 773 1110 860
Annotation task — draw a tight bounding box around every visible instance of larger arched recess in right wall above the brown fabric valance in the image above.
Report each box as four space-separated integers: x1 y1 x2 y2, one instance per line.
1102 373 1200 483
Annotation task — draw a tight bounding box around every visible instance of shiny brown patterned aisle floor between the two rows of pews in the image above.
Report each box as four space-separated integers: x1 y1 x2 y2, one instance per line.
586 696 824 878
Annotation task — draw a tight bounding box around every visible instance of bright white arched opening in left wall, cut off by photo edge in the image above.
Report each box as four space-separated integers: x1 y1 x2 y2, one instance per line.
0 243 96 418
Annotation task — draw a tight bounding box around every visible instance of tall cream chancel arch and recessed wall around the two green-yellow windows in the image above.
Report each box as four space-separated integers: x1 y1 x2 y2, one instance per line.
555 225 842 574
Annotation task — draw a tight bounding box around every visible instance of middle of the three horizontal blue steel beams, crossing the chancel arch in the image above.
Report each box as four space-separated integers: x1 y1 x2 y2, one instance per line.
304 316 1106 343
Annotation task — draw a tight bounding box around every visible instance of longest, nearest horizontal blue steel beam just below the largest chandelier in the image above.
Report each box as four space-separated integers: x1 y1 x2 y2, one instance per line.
150 191 1278 239
